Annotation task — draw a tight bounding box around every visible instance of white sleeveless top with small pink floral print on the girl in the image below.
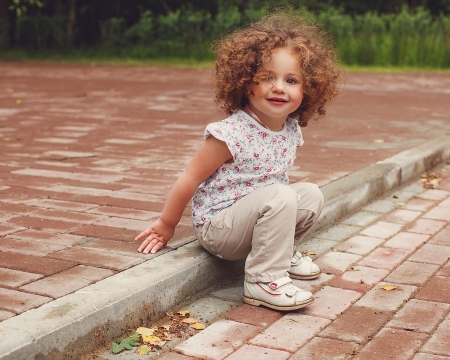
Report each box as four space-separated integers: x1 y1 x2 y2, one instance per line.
192 110 303 226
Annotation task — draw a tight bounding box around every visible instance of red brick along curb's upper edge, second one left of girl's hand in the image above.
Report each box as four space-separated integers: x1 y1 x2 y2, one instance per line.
20 265 115 299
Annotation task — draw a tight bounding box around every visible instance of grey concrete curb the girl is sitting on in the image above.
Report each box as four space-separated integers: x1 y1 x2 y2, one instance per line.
0 135 450 360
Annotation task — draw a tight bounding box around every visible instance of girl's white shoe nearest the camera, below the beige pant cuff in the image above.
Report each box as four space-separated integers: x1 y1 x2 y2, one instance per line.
243 276 315 311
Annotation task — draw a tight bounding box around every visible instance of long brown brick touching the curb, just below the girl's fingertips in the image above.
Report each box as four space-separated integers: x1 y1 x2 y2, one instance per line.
48 247 145 270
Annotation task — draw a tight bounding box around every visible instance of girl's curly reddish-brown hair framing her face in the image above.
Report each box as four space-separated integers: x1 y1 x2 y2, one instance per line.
213 11 342 127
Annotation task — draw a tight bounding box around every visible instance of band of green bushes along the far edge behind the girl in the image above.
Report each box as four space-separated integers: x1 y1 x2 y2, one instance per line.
0 5 450 68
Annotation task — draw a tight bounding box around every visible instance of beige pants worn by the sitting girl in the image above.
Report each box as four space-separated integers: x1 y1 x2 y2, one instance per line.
195 182 323 282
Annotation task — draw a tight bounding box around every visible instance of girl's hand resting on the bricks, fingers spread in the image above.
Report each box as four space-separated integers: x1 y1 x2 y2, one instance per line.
134 219 175 254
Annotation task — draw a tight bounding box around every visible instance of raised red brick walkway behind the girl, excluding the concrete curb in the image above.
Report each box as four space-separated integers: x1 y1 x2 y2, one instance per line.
0 63 450 320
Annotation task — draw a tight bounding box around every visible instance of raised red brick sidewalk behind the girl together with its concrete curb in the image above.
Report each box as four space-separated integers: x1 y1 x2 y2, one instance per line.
0 63 450 359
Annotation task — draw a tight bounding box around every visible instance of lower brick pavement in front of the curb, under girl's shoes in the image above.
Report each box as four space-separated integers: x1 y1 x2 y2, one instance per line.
92 169 450 360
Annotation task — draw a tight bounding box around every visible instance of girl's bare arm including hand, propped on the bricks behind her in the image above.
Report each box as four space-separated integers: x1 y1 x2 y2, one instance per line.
134 136 233 254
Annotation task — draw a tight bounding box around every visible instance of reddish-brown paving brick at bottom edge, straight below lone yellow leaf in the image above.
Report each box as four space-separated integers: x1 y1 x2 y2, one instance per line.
354 329 427 360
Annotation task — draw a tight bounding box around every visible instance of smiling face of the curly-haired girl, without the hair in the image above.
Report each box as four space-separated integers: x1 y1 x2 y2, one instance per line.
248 48 303 131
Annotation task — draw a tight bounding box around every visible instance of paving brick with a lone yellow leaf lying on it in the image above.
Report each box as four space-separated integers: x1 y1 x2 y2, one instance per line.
356 282 417 311
